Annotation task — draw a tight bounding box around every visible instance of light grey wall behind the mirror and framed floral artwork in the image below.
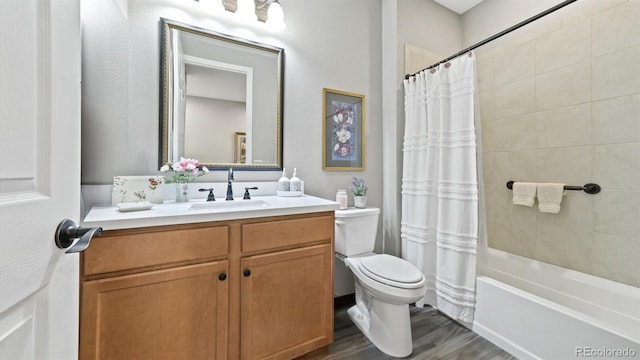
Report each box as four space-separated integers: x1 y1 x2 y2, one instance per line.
82 0 382 245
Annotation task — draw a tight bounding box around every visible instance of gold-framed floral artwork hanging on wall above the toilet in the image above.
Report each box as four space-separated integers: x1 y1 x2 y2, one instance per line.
322 89 365 170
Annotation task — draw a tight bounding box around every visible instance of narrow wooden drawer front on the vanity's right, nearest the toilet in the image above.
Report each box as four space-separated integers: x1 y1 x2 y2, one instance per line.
242 216 334 252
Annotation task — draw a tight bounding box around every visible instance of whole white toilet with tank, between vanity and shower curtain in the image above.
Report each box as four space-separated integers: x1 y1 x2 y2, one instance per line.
335 207 425 357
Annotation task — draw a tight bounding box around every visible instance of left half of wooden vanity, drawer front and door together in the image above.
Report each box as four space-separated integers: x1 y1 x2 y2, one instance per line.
80 225 229 359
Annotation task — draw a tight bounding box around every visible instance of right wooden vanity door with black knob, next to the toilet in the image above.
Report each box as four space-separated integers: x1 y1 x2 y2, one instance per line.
240 244 333 359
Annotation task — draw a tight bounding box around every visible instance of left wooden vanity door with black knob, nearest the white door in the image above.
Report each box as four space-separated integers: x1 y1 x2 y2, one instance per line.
80 260 229 360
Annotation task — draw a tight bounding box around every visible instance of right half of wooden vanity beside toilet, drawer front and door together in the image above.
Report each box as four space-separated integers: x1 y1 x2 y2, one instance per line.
240 213 334 359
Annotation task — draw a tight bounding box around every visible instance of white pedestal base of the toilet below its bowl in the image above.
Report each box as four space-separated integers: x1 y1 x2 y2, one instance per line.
347 299 413 358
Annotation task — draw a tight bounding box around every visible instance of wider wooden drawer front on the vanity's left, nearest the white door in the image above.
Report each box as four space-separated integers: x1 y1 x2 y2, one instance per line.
82 226 229 276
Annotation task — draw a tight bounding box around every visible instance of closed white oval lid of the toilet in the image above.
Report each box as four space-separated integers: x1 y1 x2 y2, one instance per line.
359 254 424 289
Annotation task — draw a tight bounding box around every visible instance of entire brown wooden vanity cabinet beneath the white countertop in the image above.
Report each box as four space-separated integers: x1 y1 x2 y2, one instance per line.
80 212 334 359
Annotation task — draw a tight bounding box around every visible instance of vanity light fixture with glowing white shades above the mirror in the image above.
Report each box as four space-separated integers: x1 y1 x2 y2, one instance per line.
195 0 287 31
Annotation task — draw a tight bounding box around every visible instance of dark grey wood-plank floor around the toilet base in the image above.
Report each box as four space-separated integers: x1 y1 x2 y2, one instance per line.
301 298 517 360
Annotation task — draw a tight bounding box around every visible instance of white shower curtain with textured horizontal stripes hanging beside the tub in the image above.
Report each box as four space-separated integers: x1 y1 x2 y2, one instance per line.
401 54 479 323
